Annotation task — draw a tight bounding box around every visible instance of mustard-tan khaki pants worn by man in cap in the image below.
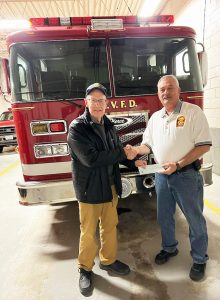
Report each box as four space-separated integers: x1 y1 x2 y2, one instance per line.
78 186 118 271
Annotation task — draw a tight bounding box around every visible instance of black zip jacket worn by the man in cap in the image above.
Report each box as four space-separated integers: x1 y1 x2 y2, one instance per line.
68 108 134 204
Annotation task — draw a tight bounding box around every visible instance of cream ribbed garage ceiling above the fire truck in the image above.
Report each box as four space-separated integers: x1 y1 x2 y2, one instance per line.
0 0 190 57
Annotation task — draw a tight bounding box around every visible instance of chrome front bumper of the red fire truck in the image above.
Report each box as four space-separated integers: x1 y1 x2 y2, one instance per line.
16 164 212 205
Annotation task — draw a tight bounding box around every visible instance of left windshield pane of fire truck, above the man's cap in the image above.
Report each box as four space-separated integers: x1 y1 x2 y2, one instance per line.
11 39 110 101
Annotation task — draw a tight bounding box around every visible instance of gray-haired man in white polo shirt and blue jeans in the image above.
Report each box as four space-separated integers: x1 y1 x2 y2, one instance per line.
127 75 212 281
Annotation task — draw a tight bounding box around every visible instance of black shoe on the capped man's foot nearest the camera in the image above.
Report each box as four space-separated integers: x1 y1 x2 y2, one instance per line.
79 268 93 297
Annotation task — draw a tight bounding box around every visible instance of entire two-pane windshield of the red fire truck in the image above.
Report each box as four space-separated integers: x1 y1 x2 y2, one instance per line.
10 37 202 102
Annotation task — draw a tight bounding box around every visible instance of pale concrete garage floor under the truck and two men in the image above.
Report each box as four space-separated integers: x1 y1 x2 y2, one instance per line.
0 148 220 300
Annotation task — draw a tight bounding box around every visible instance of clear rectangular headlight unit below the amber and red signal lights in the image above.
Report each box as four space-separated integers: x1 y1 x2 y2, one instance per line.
34 143 69 158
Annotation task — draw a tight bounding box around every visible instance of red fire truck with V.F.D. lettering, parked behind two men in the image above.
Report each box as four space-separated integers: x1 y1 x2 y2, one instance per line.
2 15 211 205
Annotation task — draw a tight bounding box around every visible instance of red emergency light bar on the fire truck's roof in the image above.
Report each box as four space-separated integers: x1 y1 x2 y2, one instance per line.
30 15 174 30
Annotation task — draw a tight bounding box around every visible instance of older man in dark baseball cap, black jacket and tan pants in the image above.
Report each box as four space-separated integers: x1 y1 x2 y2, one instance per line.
68 83 135 296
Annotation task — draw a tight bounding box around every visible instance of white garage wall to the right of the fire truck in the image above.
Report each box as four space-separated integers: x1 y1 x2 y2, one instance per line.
175 0 220 175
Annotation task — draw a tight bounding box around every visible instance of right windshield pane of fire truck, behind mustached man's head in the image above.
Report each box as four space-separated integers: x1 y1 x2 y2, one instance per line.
111 38 202 96
